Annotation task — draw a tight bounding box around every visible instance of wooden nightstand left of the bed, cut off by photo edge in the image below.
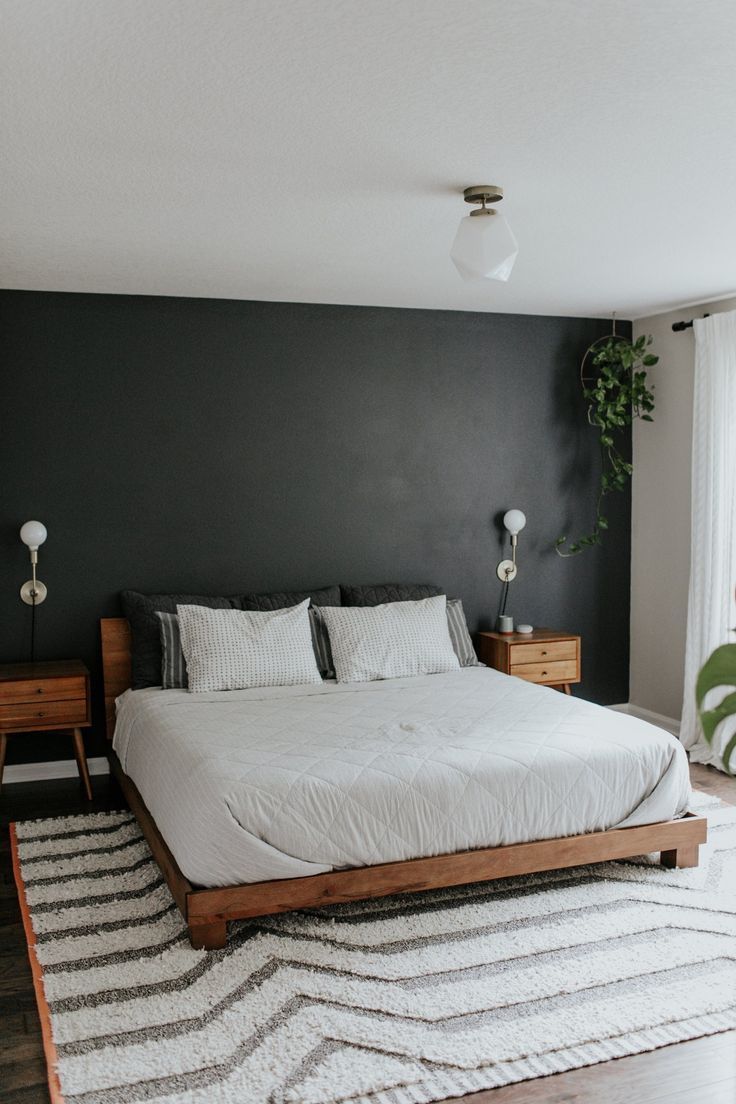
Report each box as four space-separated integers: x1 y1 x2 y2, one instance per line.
0 659 92 802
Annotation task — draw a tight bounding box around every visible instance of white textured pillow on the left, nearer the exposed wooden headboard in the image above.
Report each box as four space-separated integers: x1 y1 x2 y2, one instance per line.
177 598 322 693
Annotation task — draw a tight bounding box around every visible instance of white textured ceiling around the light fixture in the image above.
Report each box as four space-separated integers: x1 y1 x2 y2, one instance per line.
0 0 736 317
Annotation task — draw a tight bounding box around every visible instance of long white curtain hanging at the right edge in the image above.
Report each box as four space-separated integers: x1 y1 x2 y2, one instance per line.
680 310 736 771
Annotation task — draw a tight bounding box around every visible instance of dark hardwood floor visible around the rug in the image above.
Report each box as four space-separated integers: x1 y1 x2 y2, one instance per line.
0 764 736 1104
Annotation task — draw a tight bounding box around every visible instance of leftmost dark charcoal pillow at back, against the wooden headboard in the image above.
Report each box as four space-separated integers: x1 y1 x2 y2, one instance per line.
120 591 239 690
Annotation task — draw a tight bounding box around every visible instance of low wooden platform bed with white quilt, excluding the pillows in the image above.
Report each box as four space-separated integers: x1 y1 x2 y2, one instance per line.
102 618 705 948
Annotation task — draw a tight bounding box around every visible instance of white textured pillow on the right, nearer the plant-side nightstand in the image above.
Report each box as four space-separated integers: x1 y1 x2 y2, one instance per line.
320 594 460 682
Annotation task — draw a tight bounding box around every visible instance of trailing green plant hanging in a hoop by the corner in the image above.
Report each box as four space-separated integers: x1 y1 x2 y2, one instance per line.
555 325 659 556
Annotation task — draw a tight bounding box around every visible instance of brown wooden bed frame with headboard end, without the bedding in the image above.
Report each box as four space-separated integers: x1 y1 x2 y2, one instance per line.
100 617 706 949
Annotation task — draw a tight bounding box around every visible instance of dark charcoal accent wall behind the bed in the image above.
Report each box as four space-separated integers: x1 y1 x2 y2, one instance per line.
0 291 630 763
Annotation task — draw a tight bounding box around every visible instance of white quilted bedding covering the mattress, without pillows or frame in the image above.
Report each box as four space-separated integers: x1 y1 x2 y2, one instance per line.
114 667 690 887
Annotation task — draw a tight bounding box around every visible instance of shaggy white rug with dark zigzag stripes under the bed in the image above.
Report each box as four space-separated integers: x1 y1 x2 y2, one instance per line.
11 798 736 1104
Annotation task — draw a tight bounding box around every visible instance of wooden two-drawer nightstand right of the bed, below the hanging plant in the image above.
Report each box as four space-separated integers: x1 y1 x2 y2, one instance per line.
476 628 580 693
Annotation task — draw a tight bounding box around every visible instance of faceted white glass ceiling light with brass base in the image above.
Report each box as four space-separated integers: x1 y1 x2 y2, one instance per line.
450 184 519 283
